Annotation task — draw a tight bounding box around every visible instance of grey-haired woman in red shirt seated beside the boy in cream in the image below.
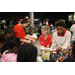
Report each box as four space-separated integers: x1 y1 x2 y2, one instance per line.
38 26 52 48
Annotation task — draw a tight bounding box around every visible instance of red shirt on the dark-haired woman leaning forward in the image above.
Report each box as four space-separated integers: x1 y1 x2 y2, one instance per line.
13 24 26 39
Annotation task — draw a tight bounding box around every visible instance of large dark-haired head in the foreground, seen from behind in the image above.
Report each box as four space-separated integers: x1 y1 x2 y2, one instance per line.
17 43 37 62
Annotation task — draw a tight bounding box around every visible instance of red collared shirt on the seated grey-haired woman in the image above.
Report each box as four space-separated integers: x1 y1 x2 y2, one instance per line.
39 35 52 47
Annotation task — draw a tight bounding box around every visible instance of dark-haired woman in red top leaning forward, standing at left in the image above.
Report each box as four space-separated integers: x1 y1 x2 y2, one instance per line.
13 18 31 44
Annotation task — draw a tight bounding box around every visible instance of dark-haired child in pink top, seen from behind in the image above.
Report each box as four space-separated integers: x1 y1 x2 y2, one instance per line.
1 37 21 62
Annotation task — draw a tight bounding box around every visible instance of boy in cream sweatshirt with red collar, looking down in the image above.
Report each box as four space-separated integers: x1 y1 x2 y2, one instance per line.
51 20 71 53
